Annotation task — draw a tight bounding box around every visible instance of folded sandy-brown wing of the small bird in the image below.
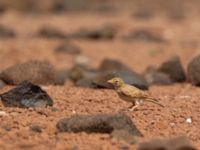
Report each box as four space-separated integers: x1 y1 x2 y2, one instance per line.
121 85 149 99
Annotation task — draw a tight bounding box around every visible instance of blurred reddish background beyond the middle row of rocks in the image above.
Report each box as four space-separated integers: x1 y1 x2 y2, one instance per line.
0 0 200 72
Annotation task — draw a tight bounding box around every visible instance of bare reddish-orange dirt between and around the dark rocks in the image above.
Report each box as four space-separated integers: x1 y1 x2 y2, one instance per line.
0 2 200 150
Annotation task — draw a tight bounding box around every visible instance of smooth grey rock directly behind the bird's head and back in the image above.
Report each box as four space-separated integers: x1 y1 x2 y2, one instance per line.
92 70 148 90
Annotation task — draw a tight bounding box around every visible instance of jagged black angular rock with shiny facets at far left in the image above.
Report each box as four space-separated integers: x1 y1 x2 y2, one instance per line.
0 81 53 108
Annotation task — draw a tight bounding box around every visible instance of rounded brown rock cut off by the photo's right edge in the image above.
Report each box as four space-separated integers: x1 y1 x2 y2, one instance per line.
187 55 200 86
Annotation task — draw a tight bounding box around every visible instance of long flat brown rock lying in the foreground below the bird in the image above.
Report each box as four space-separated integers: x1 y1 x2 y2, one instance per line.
57 114 141 144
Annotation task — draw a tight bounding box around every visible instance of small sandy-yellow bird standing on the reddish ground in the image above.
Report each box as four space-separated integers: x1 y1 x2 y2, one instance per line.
107 77 164 111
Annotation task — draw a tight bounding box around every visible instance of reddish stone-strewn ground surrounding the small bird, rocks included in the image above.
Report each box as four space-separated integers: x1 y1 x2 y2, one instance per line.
0 2 200 150
